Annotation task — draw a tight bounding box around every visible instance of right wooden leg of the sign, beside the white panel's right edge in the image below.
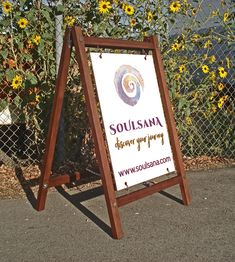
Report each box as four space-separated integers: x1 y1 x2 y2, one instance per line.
147 36 191 205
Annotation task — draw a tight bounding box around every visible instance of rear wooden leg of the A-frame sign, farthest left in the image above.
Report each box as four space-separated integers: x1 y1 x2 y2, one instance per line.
36 29 71 211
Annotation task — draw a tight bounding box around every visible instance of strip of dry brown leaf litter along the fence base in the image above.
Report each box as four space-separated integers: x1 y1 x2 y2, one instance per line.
0 156 235 199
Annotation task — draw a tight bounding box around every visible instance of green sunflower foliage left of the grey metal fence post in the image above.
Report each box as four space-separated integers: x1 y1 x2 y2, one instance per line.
0 1 56 156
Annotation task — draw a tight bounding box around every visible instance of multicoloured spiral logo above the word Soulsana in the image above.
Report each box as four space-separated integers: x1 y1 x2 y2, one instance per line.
114 65 144 106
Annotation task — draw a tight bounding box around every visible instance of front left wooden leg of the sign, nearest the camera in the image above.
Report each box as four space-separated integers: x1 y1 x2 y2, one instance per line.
72 27 123 239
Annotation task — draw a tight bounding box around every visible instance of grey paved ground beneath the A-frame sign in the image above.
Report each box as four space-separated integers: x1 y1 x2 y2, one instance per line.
0 168 235 262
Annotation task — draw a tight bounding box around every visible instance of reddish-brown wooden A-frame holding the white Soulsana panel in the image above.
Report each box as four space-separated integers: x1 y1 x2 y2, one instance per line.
36 26 191 239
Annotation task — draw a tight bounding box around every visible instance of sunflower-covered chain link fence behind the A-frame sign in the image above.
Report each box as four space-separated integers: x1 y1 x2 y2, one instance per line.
0 0 235 176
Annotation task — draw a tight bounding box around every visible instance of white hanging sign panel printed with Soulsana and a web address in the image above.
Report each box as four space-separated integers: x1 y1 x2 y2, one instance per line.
91 53 175 190
